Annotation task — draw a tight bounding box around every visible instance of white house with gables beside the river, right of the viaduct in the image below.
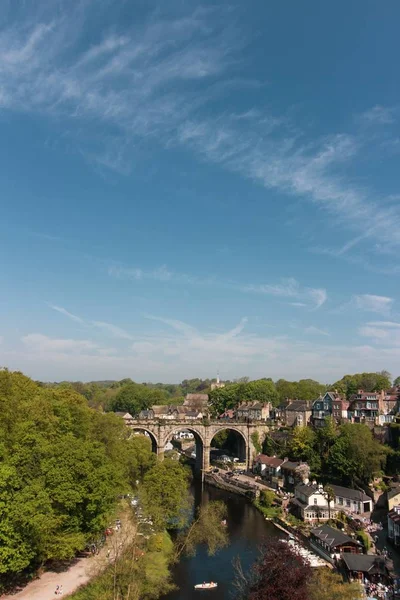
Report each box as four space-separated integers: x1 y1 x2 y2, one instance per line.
292 481 337 522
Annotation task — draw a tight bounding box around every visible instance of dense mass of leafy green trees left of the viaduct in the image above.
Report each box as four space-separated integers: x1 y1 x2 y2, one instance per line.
0 370 155 587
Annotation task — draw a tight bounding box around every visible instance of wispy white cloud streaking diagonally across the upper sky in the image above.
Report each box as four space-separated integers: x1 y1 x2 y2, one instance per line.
0 2 400 264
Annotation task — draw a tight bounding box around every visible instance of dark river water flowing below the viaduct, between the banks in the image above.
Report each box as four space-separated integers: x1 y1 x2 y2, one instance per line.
162 483 282 600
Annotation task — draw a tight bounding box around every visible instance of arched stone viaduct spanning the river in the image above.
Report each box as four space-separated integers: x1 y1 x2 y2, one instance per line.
130 419 269 474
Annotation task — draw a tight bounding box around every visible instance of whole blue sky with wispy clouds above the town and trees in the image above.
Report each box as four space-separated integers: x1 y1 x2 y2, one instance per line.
0 0 400 382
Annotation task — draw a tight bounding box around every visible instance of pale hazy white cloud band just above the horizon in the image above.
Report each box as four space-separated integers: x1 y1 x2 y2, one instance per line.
6 317 400 382
